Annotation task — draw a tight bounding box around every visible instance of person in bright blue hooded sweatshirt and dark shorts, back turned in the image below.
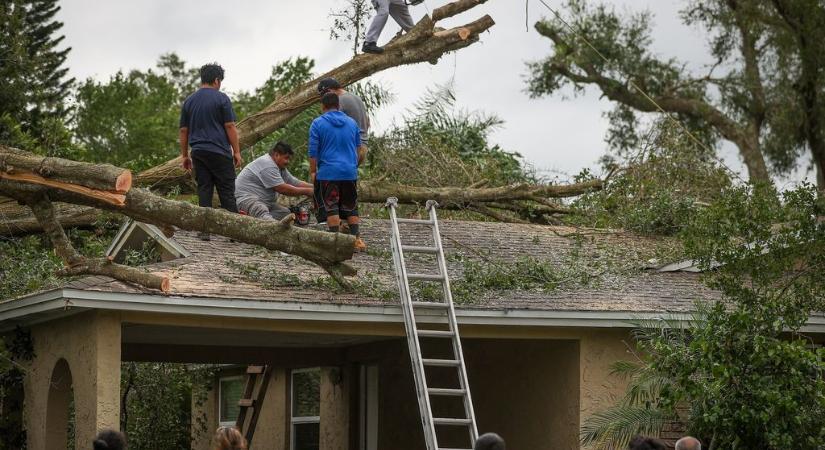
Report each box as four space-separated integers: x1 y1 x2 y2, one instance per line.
309 92 367 251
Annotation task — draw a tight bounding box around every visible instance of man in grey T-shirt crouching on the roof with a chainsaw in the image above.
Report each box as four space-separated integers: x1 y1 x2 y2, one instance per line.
235 142 312 220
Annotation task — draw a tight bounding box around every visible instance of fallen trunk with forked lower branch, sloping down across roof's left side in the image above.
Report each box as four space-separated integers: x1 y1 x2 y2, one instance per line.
0 146 356 291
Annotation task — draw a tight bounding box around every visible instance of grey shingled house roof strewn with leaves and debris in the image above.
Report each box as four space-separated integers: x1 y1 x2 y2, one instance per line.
50 219 720 313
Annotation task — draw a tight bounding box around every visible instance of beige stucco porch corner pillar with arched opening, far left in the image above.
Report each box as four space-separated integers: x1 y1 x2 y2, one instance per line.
25 312 121 450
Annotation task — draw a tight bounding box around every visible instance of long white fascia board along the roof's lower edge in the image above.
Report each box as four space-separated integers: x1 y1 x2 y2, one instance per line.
0 289 825 333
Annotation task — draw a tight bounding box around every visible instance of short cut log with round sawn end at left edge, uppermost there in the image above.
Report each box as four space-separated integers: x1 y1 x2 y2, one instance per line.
0 145 132 192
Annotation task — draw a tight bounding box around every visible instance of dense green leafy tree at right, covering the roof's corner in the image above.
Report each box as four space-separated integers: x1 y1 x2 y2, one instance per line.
582 185 825 450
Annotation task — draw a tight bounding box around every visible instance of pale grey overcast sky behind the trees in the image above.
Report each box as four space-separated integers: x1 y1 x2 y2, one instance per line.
58 0 816 185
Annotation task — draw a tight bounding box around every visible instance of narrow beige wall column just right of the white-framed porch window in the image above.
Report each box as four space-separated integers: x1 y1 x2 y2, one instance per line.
319 367 353 450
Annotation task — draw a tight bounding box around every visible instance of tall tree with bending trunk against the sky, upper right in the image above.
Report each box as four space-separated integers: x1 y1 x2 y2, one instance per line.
528 0 825 187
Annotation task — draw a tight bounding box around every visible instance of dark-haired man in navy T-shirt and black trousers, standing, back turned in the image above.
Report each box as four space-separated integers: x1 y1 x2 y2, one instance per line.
180 63 243 240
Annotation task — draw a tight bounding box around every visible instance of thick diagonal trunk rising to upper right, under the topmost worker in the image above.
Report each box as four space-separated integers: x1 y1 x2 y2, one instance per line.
135 0 495 189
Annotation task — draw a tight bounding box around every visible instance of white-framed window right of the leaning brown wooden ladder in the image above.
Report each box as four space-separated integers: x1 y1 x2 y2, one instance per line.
290 367 321 450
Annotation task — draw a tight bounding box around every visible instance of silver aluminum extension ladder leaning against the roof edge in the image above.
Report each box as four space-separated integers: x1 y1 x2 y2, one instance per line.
386 197 478 450
